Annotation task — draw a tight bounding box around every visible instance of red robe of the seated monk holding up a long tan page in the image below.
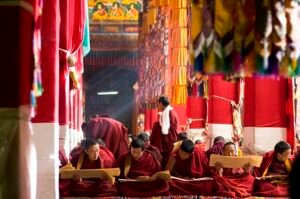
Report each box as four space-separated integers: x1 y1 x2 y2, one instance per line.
214 168 254 198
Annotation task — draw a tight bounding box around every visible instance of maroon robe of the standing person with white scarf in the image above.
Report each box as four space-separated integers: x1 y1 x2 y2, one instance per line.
150 109 179 166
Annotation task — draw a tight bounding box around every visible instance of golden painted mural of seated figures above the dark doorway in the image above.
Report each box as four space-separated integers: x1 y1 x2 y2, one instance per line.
88 0 143 22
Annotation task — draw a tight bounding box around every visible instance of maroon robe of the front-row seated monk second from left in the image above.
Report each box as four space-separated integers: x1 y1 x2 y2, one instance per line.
118 150 169 197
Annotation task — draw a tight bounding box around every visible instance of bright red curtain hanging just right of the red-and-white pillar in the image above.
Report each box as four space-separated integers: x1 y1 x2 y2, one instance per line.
59 0 86 125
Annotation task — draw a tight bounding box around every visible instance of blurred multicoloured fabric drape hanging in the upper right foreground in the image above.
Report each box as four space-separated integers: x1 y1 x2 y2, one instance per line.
192 0 300 76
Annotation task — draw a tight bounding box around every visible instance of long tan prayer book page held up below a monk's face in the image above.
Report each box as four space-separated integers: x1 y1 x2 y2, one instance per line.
209 154 262 168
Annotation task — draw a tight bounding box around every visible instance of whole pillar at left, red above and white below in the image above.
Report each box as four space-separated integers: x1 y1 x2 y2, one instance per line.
32 0 60 198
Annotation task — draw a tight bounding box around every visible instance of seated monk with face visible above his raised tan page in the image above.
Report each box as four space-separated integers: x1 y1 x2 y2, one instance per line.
213 142 254 198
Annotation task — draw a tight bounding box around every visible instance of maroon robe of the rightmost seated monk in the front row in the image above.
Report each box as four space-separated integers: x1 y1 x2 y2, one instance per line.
253 151 291 197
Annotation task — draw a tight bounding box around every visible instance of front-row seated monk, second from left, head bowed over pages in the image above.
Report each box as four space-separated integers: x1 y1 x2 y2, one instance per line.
118 139 169 197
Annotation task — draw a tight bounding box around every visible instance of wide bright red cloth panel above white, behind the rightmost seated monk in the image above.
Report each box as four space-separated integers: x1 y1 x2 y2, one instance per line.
244 77 287 127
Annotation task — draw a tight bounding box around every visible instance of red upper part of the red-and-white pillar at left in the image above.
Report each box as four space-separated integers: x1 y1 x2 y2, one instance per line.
31 1 60 123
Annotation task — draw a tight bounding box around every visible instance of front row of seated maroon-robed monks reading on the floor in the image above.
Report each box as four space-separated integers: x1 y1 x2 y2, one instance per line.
59 133 298 198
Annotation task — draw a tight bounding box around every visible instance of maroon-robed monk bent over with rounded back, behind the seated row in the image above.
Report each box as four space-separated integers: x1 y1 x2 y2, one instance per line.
82 116 129 159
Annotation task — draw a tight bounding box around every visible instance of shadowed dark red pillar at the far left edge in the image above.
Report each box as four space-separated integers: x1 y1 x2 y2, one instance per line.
0 0 41 198
